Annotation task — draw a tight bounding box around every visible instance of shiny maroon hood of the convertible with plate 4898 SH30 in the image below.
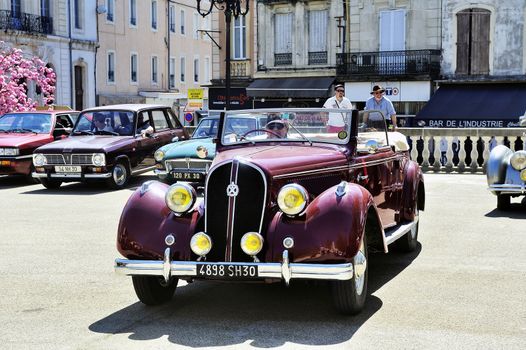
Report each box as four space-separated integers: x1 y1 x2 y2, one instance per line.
214 145 347 177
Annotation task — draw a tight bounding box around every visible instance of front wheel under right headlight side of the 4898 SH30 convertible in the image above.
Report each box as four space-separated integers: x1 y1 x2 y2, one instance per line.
332 234 369 315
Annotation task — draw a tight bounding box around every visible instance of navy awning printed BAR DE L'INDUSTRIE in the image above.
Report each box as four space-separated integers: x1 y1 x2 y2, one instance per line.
413 83 526 128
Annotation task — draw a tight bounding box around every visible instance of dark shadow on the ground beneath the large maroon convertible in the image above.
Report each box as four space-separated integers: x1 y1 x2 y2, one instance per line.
89 245 421 348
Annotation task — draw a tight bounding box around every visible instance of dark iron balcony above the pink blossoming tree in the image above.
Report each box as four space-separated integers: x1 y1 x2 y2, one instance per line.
0 10 53 34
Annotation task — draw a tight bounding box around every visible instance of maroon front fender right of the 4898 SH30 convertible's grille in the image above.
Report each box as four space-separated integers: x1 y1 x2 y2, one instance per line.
266 183 374 263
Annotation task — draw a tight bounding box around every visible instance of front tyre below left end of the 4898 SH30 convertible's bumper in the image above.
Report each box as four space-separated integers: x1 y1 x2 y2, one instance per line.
132 276 178 305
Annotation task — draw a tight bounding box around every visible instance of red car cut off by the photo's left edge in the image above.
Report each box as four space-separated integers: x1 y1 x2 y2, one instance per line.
0 110 79 180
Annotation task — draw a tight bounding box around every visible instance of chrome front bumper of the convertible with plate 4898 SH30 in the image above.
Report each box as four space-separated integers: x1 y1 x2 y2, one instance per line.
115 248 353 284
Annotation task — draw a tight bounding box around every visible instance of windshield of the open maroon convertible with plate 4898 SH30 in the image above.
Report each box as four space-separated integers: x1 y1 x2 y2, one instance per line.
222 108 358 145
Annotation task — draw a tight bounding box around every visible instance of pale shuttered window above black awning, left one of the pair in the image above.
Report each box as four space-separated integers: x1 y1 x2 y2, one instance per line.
274 13 293 66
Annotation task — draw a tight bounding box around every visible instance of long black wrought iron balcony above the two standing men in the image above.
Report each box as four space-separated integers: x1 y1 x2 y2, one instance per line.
336 50 440 80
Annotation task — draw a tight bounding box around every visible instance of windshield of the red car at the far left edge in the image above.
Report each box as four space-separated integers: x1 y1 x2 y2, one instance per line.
0 113 51 134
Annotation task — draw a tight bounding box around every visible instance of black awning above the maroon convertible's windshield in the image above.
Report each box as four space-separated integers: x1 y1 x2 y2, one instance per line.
247 78 334 98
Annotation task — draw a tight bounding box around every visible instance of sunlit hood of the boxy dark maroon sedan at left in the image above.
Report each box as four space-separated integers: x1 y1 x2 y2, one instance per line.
38 135 133 152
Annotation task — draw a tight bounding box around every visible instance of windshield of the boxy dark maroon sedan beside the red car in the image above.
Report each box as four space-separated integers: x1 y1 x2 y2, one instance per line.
72 110 134 136
